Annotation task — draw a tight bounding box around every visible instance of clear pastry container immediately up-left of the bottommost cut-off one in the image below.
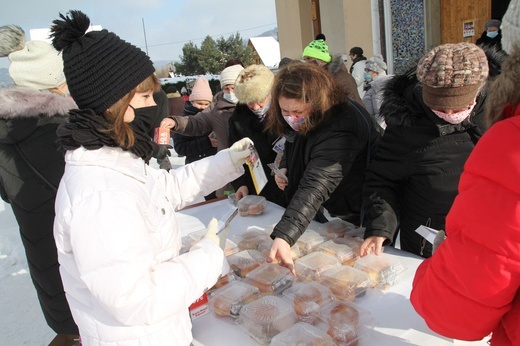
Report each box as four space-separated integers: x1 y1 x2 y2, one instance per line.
236 295 297 344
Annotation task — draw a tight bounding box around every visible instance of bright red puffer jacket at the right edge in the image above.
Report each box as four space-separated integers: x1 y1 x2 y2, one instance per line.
410 106 520 345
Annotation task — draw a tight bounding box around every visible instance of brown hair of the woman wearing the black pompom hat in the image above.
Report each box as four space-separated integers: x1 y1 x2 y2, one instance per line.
103 74 160 149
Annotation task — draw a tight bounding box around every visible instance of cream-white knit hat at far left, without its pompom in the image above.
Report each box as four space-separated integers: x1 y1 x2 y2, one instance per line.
9 41 65 90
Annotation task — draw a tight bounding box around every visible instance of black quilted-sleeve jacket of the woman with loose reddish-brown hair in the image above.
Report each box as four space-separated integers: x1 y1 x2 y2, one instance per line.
271 101 380 246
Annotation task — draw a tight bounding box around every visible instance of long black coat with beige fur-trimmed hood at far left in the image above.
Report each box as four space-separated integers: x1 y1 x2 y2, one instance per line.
0 87 78 334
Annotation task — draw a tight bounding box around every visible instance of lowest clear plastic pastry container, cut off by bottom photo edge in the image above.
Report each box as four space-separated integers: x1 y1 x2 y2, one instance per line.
271 322 336 346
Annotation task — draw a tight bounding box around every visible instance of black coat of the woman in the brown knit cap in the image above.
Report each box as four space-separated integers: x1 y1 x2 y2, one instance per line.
363 69 485 257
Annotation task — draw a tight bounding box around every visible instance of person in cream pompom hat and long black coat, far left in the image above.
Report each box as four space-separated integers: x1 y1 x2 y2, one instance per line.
0 25 79 345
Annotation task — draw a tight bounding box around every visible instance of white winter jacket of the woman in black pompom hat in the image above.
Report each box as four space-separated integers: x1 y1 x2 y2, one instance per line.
54 147 243 346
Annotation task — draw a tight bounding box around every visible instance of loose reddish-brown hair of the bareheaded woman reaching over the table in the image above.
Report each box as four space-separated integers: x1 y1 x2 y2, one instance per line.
266 60 346 136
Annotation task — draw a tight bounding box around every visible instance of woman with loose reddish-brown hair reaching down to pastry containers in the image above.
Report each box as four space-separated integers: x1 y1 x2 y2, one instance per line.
267 62 379 273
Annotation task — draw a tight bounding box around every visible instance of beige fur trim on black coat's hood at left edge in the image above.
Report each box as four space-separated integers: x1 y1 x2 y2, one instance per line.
0 86 77 120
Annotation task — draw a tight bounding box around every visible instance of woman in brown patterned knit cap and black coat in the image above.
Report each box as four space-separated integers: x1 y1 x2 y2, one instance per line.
361 43 489 257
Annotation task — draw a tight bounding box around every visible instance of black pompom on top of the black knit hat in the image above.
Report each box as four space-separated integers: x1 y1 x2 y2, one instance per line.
51 10 90 51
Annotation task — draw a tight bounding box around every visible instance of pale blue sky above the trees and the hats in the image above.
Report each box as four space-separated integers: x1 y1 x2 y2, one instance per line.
0 0 276 67
